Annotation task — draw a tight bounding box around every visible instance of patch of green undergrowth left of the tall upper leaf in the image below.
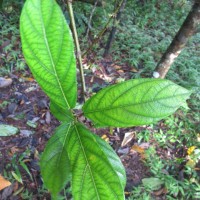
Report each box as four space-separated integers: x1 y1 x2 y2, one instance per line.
0 10 26 76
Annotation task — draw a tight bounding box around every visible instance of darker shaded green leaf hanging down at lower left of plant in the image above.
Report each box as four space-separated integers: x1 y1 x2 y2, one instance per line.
40 123 71 197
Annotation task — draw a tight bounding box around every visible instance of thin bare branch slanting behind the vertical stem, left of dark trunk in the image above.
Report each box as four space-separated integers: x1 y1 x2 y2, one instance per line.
83 0 123 57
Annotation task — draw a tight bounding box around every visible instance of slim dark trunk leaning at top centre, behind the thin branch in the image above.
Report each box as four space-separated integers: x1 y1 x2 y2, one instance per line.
103 0 127 58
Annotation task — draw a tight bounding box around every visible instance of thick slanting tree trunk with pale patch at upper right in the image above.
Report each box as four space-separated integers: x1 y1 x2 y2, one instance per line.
153 0 200 78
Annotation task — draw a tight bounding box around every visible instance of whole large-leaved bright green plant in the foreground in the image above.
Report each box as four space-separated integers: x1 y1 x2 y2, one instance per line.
20 0 190 200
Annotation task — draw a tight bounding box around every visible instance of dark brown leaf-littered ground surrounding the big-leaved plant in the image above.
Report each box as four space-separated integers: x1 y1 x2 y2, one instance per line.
0 56 198 200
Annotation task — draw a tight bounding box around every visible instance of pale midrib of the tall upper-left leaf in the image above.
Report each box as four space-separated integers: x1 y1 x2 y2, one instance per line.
40 1 70 108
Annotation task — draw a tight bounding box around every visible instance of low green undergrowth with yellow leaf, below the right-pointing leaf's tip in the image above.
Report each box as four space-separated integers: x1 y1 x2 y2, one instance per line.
128 111 200 200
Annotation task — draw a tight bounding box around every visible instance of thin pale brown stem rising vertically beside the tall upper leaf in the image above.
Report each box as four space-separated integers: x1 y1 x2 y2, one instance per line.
67 0 86 102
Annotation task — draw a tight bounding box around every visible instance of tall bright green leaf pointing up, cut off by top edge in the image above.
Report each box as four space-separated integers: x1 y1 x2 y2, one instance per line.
20 0 77 109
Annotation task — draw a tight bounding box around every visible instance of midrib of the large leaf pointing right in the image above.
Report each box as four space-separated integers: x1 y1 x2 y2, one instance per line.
84 92 190 114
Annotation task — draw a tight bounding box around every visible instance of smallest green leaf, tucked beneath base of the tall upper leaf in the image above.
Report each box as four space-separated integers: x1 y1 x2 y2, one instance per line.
50 101 73 122
